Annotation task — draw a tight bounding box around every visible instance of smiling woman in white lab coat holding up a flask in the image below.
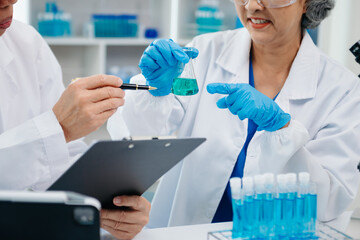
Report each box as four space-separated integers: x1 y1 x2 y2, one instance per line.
108 0 360 227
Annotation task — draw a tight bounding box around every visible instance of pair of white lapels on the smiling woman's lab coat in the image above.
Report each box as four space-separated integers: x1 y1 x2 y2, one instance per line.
216 29 320 100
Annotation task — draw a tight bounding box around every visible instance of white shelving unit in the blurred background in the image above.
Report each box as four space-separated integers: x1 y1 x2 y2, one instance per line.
28 0 236 85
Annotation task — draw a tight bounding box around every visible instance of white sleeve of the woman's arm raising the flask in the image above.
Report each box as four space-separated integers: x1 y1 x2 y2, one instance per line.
108 74 185 136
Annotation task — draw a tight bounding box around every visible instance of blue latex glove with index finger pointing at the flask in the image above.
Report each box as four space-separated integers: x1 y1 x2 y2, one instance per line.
207 83 291 132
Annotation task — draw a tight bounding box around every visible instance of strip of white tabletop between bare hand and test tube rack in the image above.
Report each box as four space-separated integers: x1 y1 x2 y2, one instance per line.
133 222 232 240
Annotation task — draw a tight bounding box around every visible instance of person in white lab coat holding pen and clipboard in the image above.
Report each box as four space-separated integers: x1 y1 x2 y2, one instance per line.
0 0 150 239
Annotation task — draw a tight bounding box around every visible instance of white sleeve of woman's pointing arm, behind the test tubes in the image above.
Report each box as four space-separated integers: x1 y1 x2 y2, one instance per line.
247 87 360 221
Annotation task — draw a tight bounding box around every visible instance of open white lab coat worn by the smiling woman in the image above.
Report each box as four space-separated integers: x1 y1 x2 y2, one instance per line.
108 29 360 227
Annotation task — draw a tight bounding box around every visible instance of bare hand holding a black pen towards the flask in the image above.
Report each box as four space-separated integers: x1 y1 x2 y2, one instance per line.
52 75 125 142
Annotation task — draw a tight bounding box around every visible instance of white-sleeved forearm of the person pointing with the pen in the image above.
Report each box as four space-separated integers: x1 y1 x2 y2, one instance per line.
0 111 69 190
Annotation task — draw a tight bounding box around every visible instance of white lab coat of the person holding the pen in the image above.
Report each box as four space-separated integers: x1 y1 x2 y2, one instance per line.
0 21 86 190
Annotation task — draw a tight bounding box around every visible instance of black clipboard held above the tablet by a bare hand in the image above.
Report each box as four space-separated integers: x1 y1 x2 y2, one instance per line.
48 138 206 209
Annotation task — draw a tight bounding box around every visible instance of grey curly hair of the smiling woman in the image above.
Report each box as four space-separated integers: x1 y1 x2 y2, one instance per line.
301 0 335 29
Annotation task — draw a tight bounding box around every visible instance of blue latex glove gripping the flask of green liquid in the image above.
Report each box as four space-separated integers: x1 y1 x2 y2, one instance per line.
139 39 199 96
